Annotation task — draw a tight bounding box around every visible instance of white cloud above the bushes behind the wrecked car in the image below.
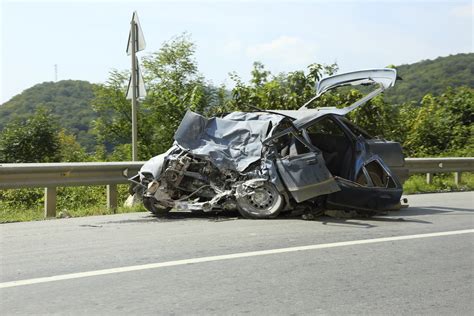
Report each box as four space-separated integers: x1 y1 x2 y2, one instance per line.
245 36 317 69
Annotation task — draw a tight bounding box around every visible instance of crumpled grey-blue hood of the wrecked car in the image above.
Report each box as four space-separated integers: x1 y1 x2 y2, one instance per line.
174 111 283 172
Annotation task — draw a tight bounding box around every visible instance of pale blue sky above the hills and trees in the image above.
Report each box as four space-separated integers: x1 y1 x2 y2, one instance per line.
0 0 474 103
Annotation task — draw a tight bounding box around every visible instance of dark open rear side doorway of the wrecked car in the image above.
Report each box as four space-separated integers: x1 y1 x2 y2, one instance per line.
306 116 353 179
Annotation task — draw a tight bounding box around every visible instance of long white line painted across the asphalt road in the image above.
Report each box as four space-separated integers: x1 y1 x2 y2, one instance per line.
0 229 474 289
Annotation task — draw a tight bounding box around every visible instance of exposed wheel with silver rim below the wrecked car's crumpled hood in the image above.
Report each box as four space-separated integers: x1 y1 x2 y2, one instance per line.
237 182 284 219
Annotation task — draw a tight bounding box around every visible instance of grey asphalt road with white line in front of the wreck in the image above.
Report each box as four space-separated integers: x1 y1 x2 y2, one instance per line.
0 192 474 315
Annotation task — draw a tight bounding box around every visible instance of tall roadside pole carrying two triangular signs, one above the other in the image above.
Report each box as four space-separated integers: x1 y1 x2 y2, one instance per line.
127 12 146 161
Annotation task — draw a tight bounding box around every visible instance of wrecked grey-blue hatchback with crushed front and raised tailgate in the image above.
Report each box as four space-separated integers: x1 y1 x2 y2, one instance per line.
130 69 407 219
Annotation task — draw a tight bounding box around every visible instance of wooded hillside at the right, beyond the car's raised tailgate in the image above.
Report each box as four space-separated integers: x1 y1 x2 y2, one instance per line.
385 53 474 104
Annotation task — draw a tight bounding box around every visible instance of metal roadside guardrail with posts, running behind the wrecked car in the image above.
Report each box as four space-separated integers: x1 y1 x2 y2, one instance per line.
0 157 474 217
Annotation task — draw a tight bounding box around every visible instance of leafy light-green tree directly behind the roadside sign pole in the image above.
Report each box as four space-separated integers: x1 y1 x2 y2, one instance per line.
92 34 216 160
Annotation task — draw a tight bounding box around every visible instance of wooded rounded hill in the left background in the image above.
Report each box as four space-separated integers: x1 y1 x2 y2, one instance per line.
0 80 96 150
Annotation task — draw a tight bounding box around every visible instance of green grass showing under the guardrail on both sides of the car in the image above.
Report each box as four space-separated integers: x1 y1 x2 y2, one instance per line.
0 172 474 223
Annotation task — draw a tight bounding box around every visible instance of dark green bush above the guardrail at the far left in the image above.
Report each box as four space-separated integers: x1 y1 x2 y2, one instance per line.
0 108 61 163
